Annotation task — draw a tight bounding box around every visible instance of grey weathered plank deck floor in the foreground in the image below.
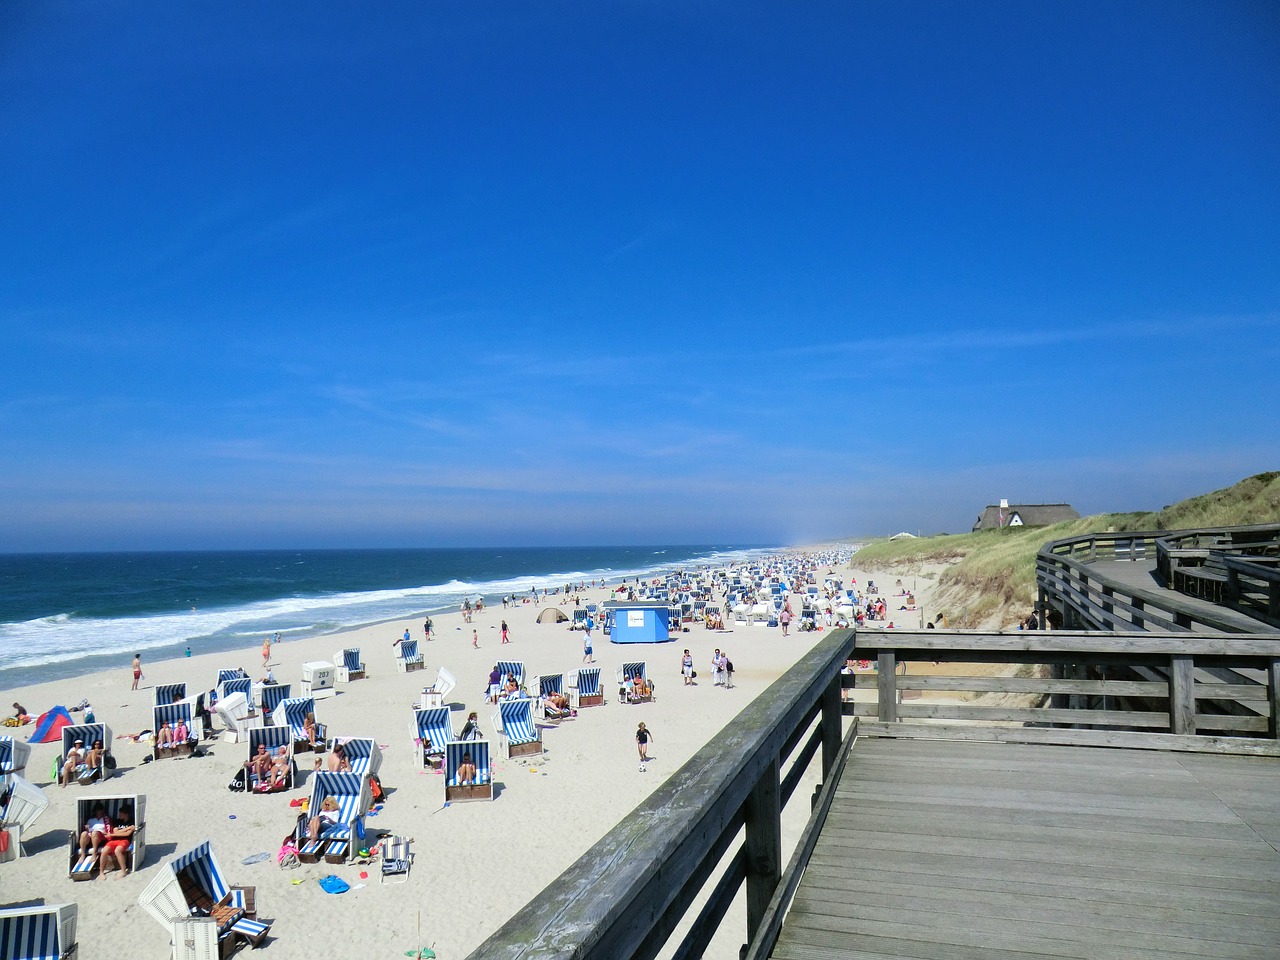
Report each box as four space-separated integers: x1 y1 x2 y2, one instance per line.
772 737 1280 960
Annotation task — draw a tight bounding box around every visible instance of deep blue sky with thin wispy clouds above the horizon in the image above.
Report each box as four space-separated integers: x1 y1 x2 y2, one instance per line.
0 0 1280 550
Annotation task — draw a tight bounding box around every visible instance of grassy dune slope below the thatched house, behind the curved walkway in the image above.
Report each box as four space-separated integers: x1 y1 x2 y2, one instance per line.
854 472 1280 628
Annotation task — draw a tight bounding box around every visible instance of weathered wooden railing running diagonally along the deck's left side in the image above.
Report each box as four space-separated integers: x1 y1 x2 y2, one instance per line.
471 630 854 960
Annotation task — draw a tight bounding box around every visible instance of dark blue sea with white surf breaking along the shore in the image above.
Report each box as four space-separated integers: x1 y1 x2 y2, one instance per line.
0 544 768 689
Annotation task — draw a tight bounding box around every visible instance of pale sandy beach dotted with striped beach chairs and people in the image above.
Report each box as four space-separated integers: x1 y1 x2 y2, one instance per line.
0 568 932 960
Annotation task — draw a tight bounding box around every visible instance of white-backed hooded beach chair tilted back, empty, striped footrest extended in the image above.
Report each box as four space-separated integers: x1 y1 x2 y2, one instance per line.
138 840 270 960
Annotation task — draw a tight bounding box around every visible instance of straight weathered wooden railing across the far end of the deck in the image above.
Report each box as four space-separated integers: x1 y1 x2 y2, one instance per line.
844 630 1280 755
